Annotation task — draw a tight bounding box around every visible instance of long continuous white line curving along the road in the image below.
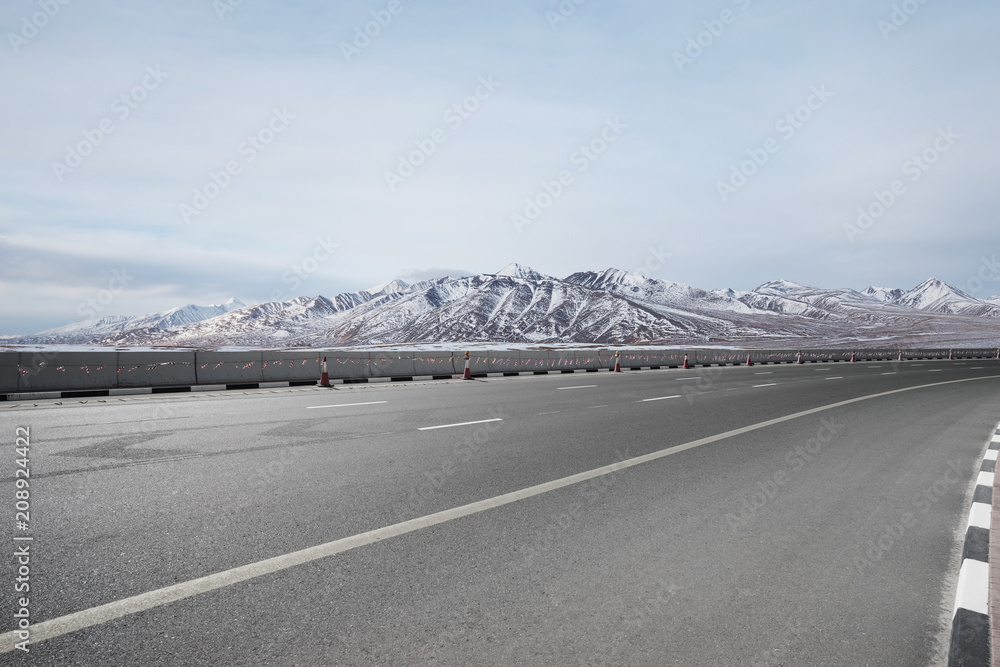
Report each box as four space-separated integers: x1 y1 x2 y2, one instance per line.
7 375 1000 653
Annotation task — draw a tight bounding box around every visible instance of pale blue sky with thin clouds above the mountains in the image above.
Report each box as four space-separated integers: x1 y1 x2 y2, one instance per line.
0 0 1000 334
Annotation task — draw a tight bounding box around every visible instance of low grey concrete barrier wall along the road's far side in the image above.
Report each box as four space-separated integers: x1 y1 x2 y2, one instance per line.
0 348 997 394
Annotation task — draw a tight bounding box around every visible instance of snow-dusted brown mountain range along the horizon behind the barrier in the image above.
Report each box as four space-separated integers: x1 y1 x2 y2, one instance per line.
7 264 1000 348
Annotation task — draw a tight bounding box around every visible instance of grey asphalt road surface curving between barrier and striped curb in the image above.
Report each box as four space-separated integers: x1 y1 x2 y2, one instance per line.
0 360 1000 666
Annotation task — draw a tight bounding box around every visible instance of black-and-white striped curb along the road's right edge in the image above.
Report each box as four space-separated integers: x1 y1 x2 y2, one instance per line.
948 426 1000 667
